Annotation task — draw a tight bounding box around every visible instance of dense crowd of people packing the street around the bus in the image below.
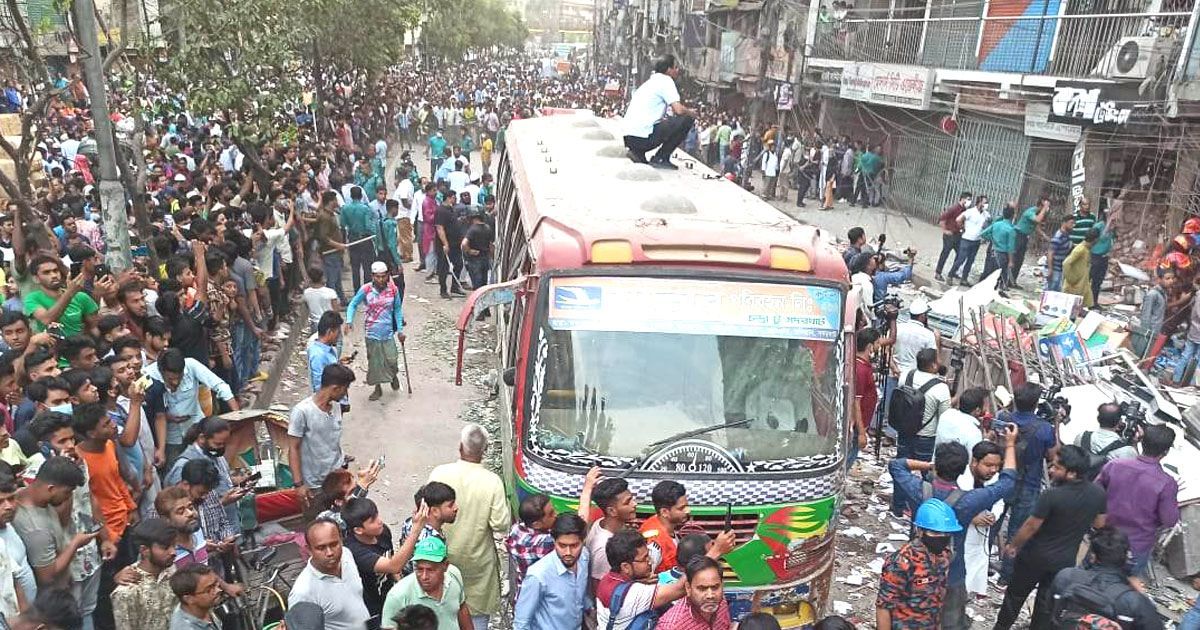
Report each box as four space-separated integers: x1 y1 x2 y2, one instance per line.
0 46 1200 630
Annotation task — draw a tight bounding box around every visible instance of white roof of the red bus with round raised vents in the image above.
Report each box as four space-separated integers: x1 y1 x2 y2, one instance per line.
505 110 847 282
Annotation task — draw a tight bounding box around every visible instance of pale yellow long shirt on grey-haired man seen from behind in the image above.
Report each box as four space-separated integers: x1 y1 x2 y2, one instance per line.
430 460 511 614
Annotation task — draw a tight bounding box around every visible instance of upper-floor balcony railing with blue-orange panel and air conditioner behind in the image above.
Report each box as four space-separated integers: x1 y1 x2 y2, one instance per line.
811 10 1190 78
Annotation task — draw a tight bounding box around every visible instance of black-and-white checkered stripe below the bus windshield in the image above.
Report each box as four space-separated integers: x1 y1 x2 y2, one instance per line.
523 457 842 505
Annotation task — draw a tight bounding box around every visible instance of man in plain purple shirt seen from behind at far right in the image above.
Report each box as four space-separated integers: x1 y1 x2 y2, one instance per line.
1096 425 1180 576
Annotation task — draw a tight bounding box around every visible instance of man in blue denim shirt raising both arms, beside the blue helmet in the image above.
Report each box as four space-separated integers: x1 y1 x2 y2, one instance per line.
880 426 1018 630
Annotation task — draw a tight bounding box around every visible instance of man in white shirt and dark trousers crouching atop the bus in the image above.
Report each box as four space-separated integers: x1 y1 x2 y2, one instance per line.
624 54 696 169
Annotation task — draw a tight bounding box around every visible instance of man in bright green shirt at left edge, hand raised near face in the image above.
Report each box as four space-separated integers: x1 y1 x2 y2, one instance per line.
25 256 100 337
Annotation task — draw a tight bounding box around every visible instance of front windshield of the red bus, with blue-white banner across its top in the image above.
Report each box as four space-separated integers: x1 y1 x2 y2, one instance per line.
530 277 842 469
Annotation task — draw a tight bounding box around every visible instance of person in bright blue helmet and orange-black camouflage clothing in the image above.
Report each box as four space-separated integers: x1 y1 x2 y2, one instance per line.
875 499 962 630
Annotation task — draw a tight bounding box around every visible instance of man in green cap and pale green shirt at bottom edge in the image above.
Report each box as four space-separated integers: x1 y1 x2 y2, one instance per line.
379 536 472 630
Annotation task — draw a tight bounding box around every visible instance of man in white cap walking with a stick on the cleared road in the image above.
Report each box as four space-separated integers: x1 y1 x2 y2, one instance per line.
346 260 404 401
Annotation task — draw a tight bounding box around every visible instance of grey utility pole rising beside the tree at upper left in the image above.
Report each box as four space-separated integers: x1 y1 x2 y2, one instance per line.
71 0 132 272
